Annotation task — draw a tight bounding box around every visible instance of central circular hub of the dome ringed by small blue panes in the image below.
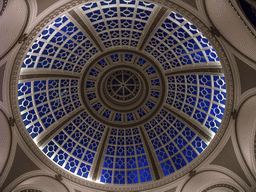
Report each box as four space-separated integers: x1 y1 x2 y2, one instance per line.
81 49 166 128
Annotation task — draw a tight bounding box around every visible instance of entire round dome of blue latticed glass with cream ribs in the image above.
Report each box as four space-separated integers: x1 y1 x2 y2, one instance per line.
17 0 226 187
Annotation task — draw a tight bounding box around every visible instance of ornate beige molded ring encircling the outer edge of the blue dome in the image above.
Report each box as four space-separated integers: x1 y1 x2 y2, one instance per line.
10 0 234 191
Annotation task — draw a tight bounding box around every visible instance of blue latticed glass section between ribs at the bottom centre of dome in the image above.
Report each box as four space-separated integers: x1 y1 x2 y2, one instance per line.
100 127 152 184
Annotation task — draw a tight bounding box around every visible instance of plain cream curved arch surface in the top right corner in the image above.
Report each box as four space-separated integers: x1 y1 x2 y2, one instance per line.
205 0 256 60
